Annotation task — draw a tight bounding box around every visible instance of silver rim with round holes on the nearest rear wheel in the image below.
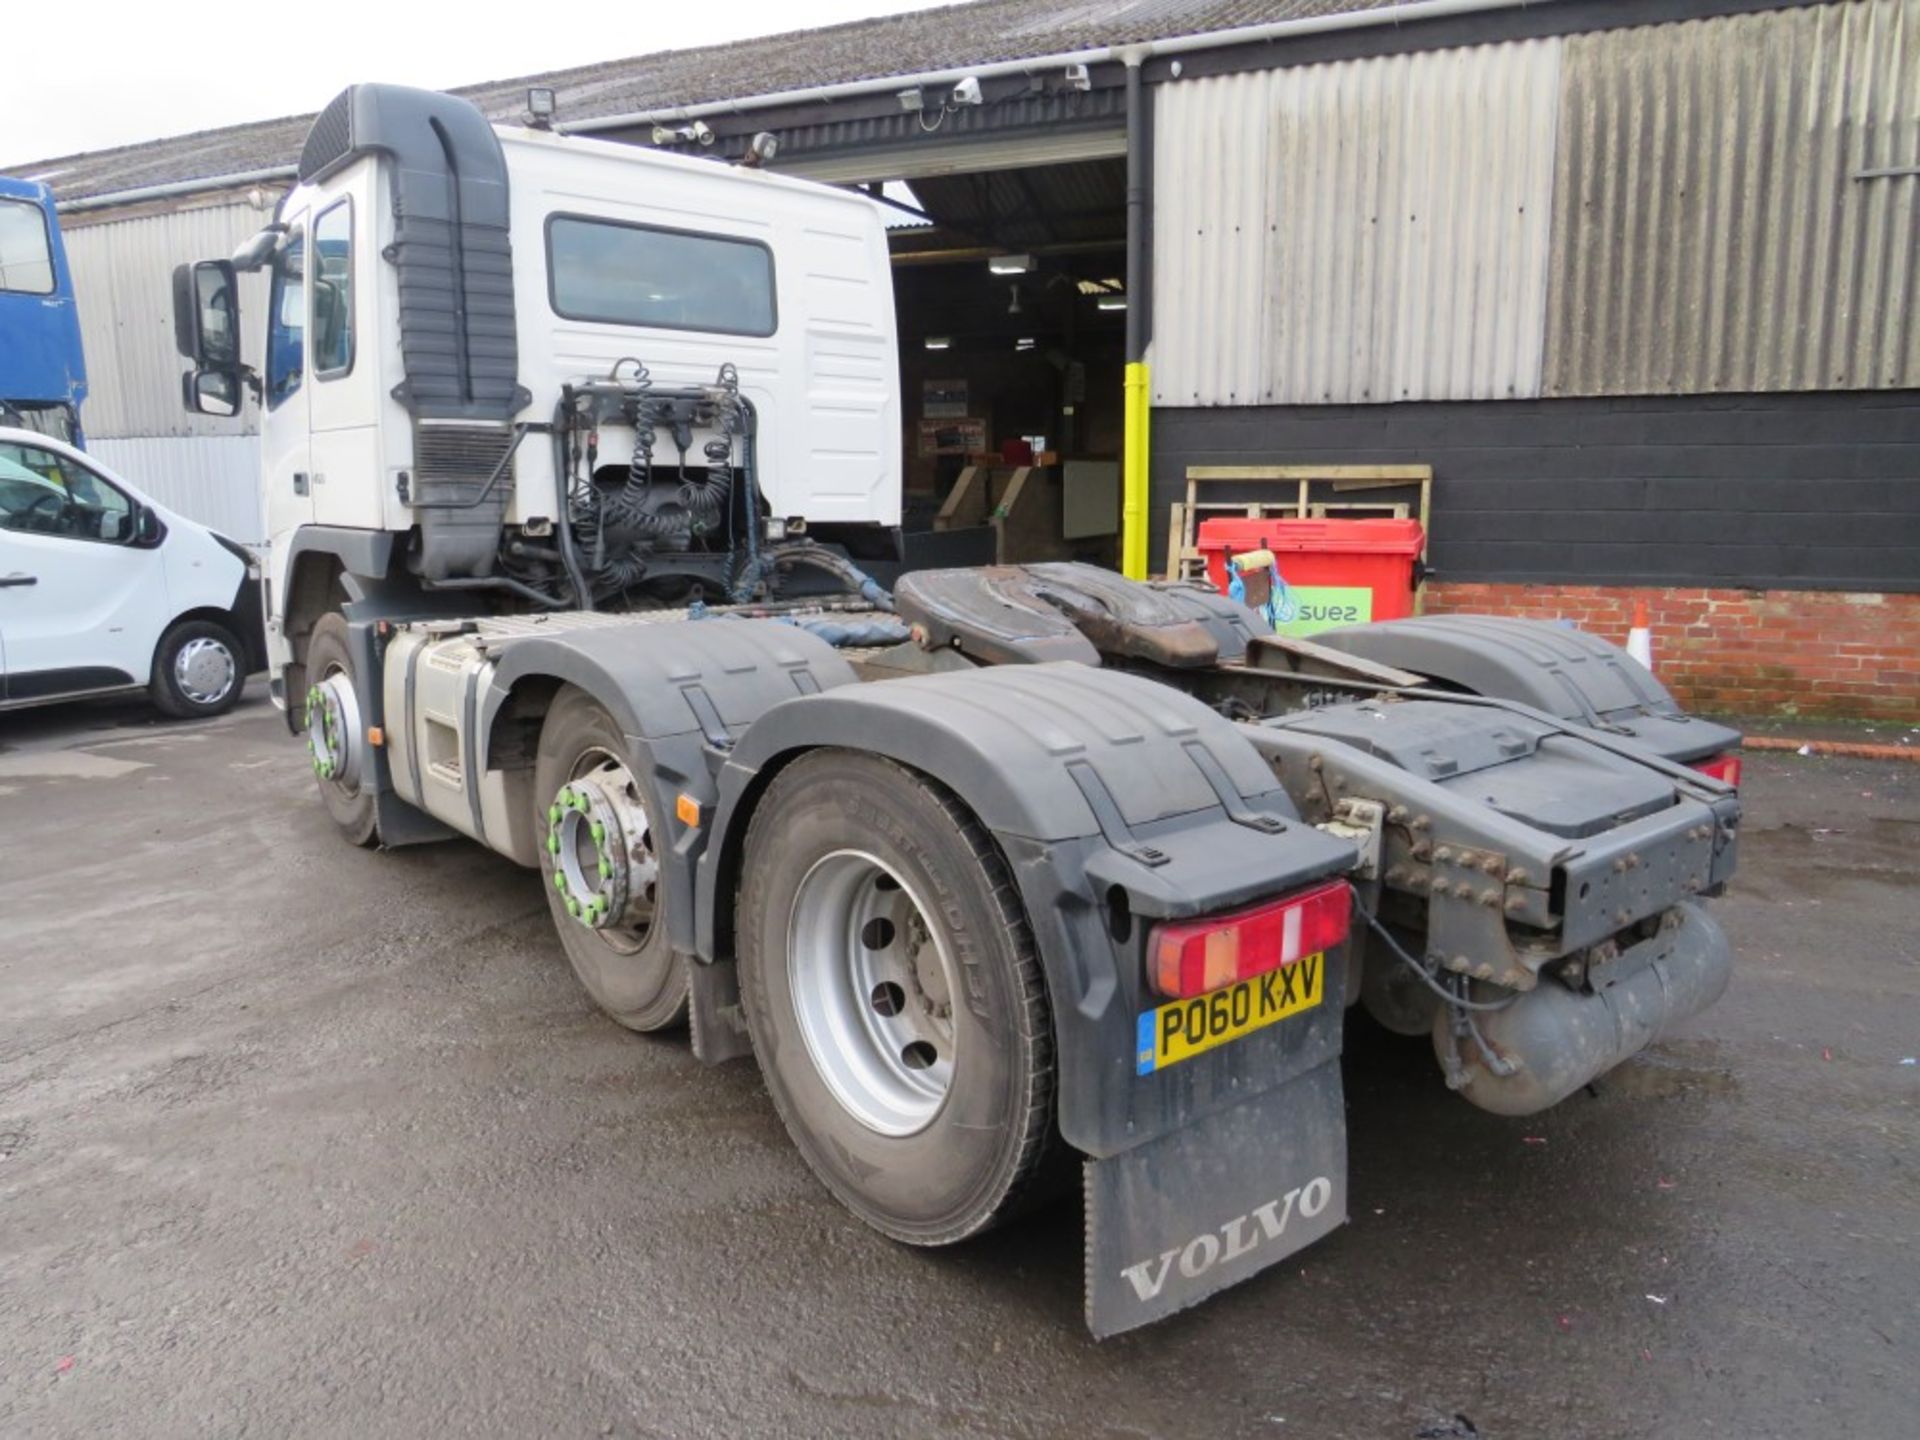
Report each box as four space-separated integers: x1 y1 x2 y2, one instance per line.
787 851 956 1137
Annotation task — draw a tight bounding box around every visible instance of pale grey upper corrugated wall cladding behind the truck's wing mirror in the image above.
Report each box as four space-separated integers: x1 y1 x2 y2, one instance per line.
63 194 278 439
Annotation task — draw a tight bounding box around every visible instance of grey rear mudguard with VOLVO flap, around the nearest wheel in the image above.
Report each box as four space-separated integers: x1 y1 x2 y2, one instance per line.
697 664 1354 1334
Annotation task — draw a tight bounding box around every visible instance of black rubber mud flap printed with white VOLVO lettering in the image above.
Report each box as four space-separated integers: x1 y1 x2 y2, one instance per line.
1087 1056 1346 1340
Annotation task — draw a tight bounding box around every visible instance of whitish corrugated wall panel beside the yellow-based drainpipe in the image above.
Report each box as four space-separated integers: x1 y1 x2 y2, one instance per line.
1152 38 1561 405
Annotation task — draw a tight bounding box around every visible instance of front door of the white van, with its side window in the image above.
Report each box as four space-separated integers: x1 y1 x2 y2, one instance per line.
0 440 173 701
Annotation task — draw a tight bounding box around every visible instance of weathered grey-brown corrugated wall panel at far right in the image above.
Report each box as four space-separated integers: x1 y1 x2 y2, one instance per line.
1546 0 1920 396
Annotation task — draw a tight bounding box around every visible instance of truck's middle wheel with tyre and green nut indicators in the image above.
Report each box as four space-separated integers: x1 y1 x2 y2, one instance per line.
534 685 687 1031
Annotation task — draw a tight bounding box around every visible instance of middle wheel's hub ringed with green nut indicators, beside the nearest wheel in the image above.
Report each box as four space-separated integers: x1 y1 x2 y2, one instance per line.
547 762 660 931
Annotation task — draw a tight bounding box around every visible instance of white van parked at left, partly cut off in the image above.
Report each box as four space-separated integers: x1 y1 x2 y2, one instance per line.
0 426 265 716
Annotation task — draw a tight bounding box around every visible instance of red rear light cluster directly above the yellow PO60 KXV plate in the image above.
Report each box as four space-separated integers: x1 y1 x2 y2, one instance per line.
1146 879 1354 1000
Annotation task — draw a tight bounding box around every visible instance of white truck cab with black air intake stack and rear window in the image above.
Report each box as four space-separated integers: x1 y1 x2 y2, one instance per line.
175 86 900 718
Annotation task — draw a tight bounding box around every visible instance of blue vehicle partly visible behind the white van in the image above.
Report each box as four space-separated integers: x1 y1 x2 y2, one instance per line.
0 177 86 445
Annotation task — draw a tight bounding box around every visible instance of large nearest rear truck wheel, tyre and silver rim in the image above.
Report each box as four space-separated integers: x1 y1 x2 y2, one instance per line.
739 751 1054 1246
